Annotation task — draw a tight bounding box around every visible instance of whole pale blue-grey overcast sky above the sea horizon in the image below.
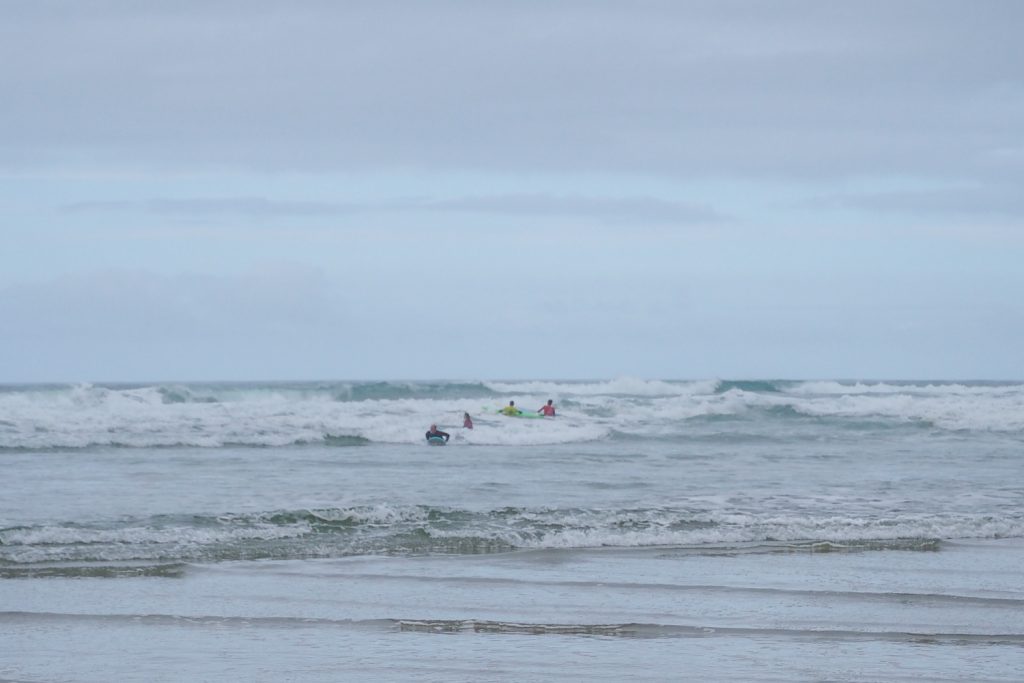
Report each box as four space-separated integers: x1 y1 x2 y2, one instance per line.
0 0 1024 382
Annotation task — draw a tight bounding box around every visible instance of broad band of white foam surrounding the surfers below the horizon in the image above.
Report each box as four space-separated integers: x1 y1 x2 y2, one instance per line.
0 379 1024 449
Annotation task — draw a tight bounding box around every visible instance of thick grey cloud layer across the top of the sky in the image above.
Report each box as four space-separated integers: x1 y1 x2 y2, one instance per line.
0 0 1024 176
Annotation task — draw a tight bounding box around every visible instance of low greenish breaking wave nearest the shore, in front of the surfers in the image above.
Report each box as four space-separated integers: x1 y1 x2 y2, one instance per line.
0 505 1024 575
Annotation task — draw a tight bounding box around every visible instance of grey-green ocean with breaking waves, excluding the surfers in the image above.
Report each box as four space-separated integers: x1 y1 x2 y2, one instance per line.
0 378 1024 682
